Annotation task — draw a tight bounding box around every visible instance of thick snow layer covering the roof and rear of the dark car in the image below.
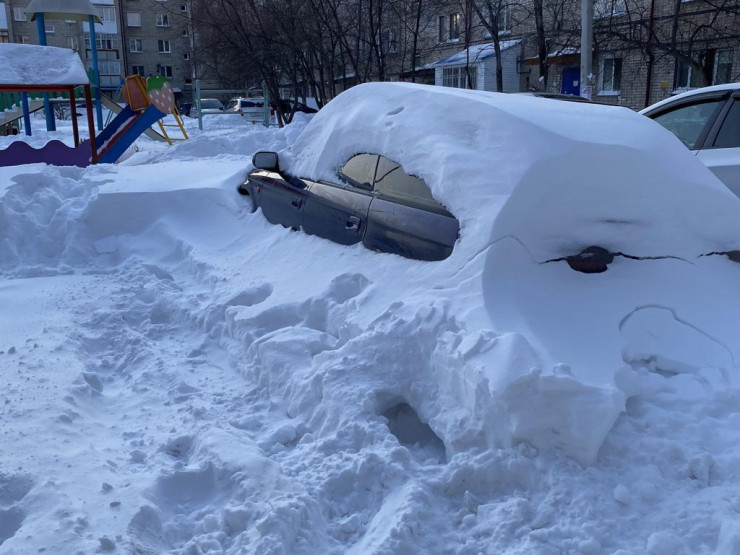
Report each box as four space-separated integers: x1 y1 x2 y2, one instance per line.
280 83 740 261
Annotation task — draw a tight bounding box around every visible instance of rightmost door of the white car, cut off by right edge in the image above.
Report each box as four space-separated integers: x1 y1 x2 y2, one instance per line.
697 93 740 196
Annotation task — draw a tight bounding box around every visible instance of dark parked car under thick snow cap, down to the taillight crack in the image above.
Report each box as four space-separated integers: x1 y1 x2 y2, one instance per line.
239 83 740 274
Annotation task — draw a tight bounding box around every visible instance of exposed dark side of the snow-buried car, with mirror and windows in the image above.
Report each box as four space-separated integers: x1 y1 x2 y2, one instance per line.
239 152 460 260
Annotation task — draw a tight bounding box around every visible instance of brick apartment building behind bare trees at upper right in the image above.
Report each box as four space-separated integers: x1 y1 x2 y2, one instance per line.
417 0 740 109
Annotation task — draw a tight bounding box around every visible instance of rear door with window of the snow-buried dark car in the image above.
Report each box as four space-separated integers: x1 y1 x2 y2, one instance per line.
363 156 459 260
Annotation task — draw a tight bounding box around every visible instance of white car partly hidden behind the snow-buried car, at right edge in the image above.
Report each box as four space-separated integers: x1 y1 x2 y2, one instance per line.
640 83 740 196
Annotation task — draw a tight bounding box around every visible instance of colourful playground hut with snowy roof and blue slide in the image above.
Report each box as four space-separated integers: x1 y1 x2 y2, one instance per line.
0 44 188 167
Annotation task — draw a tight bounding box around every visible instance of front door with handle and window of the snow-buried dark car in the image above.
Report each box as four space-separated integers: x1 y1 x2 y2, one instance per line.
303 154 378 245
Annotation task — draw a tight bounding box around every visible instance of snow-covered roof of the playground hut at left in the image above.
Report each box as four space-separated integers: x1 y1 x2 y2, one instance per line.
0 43 90 86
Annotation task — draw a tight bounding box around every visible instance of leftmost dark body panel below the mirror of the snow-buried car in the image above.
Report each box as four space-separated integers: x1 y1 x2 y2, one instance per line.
249 171 308 229
